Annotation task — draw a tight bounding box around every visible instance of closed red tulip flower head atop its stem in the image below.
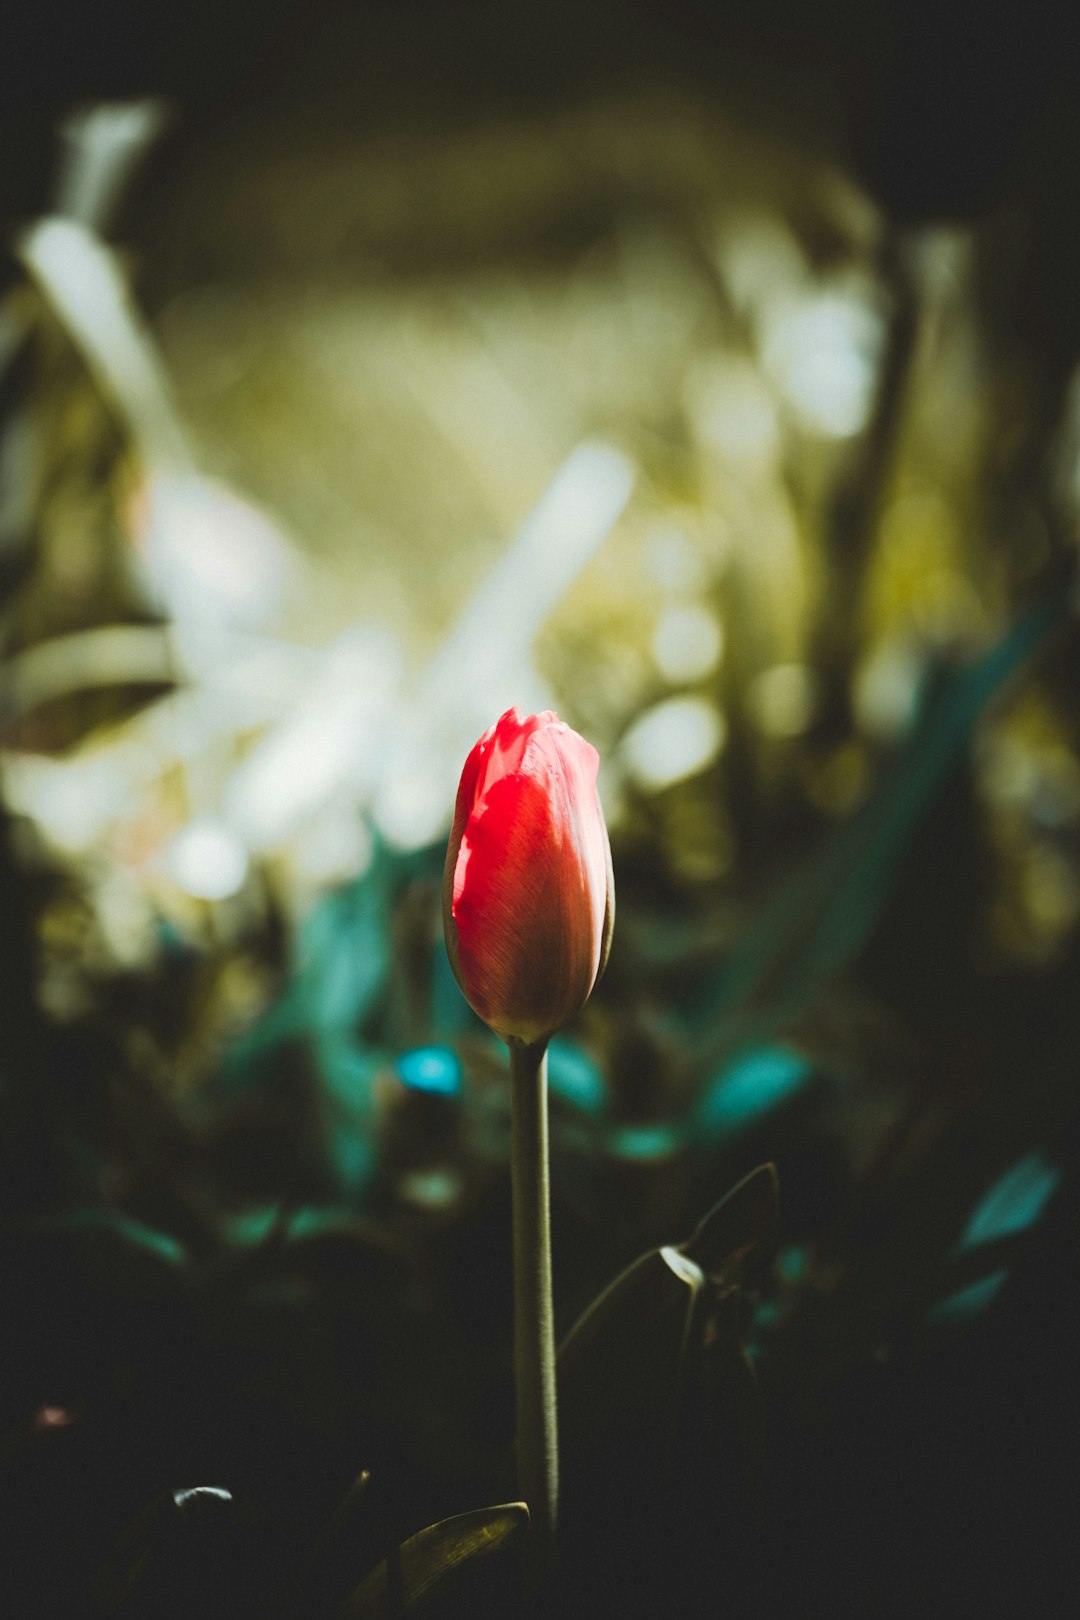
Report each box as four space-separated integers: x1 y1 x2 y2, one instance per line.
442 708 615 1045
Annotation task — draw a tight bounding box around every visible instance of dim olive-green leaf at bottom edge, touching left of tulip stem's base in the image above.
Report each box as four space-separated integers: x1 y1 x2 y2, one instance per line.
340 1502 529 1620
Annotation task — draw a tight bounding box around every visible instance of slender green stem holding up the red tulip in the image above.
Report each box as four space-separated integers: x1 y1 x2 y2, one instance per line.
508 1040 559 1597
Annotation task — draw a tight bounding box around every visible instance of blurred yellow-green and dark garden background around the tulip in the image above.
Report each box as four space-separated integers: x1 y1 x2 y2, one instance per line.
0 0 1080 1617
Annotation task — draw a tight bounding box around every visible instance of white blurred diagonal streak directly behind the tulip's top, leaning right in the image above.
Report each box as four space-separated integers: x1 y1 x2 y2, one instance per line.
372 442 635 849
